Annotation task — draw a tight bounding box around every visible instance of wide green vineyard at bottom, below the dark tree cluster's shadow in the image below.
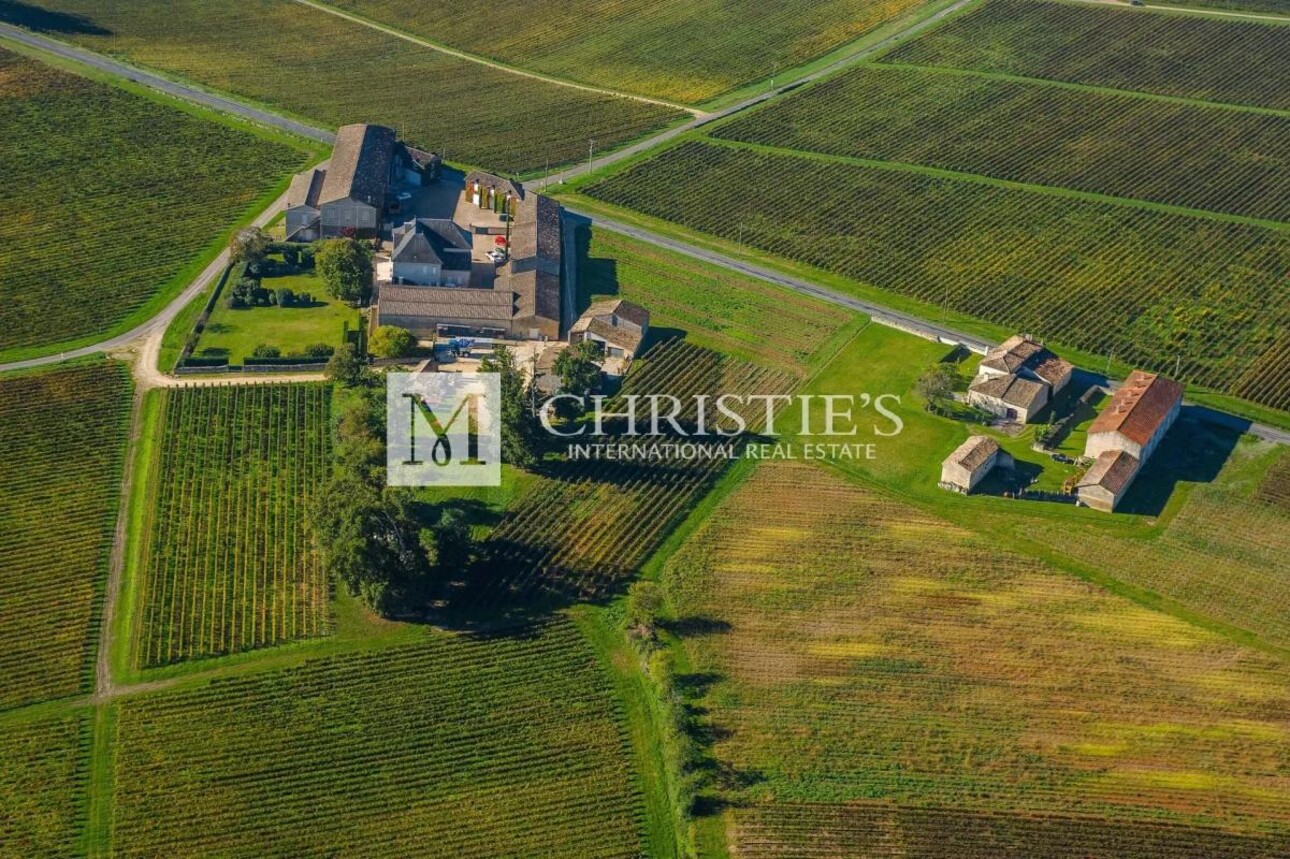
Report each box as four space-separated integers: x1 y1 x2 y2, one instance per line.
112 620 644 859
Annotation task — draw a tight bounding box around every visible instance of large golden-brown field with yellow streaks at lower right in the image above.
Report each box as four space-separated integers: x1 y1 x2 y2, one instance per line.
664 463 1290 859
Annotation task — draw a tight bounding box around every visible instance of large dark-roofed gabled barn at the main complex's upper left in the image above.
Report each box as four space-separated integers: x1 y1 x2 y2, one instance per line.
286 124 439 241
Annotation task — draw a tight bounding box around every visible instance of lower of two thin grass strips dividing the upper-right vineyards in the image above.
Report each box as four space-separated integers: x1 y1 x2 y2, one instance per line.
703 137 1290 232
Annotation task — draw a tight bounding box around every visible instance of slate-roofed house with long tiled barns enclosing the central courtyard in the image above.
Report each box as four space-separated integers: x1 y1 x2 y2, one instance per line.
373 172 571 341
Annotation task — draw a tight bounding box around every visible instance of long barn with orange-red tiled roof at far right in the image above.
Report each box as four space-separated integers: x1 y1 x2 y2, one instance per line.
1076 370 1183 513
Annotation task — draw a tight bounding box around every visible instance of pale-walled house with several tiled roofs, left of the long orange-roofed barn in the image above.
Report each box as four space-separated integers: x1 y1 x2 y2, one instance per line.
968 334 1075 423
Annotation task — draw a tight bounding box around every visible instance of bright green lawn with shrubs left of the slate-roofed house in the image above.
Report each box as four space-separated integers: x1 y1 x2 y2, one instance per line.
194 273 360 364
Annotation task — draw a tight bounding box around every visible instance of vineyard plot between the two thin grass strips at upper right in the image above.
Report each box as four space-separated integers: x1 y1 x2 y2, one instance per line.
716 64 1290 221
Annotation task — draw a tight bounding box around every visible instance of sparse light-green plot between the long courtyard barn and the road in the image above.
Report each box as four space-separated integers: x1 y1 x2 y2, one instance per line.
578 230 855 374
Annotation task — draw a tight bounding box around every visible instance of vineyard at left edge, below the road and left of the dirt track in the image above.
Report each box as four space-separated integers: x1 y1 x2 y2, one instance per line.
0 361 130 709
